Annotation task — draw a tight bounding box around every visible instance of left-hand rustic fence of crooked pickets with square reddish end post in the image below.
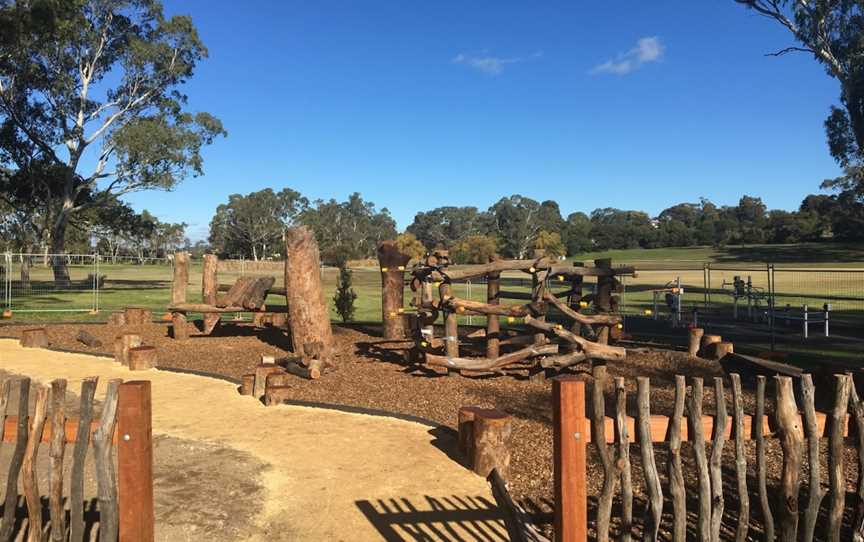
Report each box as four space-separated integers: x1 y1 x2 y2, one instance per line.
0 377 154 542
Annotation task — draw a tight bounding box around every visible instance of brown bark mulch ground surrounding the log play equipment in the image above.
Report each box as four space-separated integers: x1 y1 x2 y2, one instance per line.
0 322 857 533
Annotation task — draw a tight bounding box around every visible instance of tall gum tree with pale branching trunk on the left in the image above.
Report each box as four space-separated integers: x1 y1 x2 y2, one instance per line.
0 0 225 283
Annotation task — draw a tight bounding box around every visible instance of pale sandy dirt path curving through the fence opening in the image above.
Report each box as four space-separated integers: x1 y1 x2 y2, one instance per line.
0 340 505 541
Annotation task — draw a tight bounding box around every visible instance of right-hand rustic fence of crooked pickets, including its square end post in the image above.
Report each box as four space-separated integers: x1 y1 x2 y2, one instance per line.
553 367 864 542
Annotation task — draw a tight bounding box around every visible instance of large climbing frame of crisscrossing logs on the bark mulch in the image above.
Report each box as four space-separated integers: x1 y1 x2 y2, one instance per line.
379 251 635 376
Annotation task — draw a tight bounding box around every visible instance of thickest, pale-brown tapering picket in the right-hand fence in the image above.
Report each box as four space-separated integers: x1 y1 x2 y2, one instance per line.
774 376 804 542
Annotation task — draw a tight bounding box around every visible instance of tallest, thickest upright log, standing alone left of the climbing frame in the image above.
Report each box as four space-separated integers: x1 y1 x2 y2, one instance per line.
285 226 333 360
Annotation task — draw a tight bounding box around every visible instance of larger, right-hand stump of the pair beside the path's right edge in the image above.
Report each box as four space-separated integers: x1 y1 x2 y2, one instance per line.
472 410 513 482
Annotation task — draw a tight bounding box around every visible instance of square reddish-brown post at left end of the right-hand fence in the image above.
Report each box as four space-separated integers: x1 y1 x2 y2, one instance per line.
552 376 588 542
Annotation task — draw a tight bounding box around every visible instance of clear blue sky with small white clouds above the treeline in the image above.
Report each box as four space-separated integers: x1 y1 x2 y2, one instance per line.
126 0 838 240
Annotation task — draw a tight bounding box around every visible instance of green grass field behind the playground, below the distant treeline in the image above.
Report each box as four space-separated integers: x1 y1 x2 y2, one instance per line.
3 244 864 328
